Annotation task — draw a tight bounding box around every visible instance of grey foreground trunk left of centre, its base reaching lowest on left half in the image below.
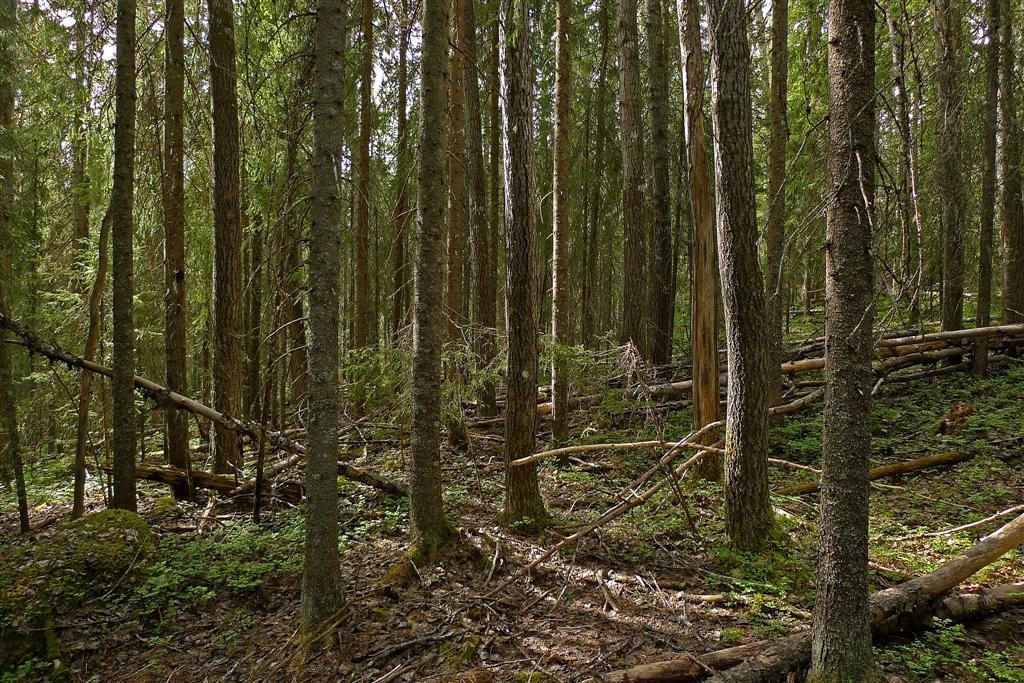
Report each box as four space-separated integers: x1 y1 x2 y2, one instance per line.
302 0 345 633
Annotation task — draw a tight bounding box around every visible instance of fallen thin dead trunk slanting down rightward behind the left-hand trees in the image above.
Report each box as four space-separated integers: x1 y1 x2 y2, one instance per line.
0 314 404 495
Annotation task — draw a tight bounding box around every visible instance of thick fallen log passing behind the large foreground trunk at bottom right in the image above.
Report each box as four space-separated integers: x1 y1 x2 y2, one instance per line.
599 515 1024 683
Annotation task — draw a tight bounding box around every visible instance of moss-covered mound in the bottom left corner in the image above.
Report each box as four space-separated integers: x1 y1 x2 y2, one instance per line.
0 510 156 670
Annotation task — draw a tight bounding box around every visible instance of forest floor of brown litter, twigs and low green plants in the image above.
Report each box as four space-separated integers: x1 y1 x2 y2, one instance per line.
0 339 1024 683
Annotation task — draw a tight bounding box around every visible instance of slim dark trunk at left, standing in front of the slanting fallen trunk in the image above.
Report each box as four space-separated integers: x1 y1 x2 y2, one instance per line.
111 0 136 510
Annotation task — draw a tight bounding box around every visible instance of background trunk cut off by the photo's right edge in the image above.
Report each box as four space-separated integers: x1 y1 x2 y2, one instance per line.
999 0 1024 325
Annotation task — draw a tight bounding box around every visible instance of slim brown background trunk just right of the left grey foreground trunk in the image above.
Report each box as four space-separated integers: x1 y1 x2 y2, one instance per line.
354 0 376 348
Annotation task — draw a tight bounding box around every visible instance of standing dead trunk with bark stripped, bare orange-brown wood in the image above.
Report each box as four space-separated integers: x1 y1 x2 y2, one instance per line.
679 0 722 481
